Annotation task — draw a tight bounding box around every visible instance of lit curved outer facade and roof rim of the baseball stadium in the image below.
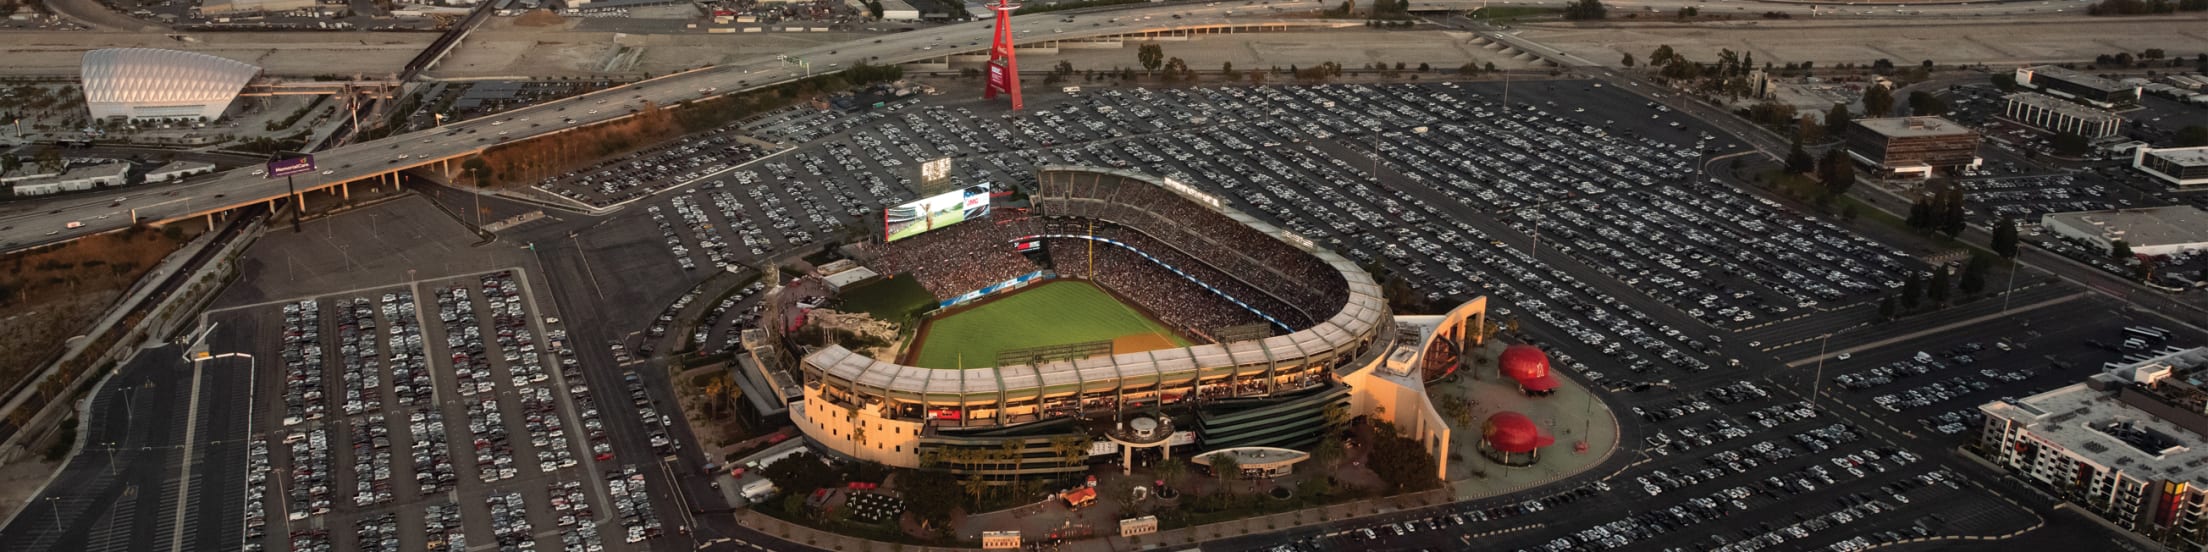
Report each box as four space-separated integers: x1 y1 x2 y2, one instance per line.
790 166 1486 481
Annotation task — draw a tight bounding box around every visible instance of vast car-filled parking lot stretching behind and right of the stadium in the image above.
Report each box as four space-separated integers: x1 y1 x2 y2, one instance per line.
565 82 1908 386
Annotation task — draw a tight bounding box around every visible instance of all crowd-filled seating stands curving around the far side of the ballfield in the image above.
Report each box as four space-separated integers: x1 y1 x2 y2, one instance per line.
870 167 1349 351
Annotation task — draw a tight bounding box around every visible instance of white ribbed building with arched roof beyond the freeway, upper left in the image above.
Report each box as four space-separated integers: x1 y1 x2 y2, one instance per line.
79 49 261 121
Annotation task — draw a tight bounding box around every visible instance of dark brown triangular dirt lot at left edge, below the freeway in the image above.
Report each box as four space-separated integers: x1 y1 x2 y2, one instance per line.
0 225 199 397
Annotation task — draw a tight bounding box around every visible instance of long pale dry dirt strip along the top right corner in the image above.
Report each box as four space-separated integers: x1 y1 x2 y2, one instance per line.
1519 15 2208 66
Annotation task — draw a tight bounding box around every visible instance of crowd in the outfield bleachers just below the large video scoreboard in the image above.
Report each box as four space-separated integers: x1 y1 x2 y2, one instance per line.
874 212 1036 300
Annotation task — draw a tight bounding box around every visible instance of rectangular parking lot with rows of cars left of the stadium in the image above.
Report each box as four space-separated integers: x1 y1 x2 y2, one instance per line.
212 269 658 552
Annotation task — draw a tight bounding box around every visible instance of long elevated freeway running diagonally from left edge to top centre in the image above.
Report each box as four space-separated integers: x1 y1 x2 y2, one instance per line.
0 2 1360 250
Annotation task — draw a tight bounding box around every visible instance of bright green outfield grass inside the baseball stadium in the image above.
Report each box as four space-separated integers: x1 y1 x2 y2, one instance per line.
912 280 1188 369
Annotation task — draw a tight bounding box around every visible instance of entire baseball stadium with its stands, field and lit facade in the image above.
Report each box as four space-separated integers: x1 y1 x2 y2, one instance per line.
790 166 1486 479
